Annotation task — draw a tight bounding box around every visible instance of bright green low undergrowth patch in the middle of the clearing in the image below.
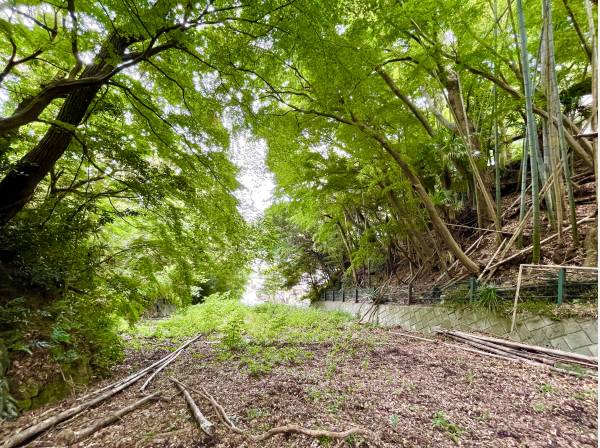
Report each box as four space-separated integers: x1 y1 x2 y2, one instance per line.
122 294 356 376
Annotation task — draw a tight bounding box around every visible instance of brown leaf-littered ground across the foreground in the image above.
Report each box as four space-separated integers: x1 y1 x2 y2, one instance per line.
0 329 597 447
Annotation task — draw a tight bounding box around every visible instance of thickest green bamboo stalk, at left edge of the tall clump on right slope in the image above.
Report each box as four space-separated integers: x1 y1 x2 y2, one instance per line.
517 0 541 263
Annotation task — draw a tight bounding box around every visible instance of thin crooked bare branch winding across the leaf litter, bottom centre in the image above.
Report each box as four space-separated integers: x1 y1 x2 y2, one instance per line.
170 378 373 442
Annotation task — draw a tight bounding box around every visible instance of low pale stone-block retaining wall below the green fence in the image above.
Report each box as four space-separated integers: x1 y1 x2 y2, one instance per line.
312 301 598 356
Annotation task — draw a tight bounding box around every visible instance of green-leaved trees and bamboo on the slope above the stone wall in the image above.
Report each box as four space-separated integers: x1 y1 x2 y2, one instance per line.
255 0 597 283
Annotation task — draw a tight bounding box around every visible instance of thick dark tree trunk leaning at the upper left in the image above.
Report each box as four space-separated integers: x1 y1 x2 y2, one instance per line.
0 33 131 225
